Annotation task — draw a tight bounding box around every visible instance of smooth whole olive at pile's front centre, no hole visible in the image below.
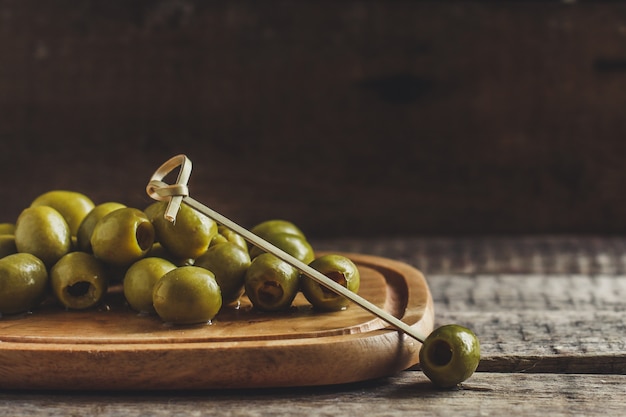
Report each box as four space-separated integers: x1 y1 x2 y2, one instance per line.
152 265 222 324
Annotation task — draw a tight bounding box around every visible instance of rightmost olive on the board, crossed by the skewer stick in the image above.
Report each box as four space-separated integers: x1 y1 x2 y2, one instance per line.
300 254 361 311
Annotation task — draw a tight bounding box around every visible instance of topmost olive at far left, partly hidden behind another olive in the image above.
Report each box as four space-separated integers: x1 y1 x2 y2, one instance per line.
30 190 94 236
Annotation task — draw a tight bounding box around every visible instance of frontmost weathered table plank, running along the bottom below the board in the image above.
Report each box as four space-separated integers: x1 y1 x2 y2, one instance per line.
0 372 626 417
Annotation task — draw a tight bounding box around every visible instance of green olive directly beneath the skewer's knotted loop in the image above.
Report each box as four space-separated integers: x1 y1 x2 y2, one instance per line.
144 201 217 259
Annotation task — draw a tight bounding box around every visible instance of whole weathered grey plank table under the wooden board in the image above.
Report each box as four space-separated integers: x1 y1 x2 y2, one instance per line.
0 236 626 417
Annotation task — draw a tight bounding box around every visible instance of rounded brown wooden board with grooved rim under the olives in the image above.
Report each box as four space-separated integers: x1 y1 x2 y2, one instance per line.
0 254 434 390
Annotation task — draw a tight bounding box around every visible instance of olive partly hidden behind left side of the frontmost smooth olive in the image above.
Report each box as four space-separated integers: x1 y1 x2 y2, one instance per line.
124 257 176 313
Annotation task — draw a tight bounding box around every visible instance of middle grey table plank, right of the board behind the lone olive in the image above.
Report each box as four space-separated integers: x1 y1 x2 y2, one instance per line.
429 275 626 374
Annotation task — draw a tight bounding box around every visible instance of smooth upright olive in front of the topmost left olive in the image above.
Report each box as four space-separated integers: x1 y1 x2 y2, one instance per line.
15 206 72 268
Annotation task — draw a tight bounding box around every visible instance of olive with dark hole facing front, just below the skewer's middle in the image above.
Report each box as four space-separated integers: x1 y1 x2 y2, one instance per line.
244 253 300 311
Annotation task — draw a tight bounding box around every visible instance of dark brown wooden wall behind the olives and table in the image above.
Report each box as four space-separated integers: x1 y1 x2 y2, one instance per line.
0 0 626 236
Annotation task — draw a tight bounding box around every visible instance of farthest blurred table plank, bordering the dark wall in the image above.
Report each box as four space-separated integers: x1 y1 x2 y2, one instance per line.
313 234 626 274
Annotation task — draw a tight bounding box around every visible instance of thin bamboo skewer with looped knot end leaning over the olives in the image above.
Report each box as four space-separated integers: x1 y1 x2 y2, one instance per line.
146 155 425 343
